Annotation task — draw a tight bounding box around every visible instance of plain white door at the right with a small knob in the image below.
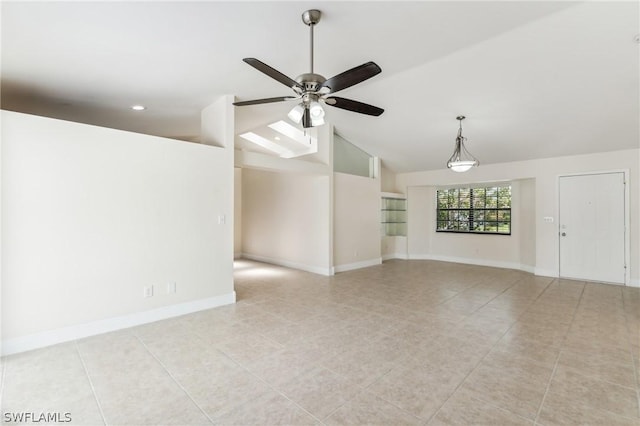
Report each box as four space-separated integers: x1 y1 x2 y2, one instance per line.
560 172 625 284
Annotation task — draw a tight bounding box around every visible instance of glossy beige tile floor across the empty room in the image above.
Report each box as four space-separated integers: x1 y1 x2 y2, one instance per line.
1 260 640 425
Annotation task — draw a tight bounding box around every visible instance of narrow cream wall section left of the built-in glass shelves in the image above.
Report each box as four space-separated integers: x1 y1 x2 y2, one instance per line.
333 173 381 272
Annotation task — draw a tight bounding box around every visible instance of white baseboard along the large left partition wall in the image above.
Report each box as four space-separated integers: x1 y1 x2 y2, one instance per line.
2 291 236 356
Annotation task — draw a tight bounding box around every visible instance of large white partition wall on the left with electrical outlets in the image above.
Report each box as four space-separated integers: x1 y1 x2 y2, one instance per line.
2 111 235 352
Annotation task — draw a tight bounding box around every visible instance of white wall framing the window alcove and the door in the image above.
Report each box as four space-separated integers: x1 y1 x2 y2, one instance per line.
397 149 640 286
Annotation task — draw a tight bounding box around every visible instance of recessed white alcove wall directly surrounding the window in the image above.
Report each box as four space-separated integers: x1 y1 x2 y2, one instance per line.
408 180 535 272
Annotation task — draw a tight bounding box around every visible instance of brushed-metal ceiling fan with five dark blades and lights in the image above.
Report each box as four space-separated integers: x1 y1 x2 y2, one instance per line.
233 9 384 128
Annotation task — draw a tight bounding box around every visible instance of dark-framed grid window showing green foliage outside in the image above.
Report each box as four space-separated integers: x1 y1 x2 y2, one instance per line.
436 186 511 235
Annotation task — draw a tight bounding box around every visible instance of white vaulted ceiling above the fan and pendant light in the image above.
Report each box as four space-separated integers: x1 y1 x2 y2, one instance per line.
1 1 640 172
